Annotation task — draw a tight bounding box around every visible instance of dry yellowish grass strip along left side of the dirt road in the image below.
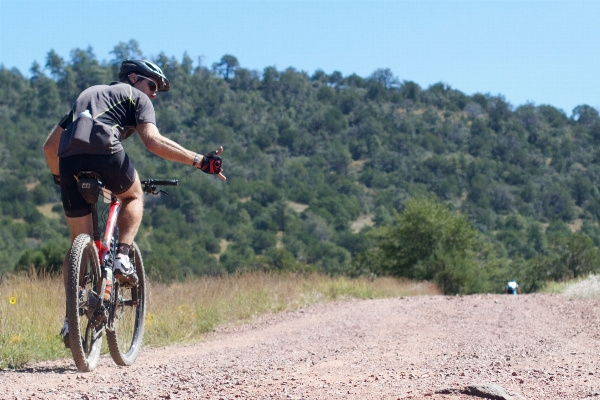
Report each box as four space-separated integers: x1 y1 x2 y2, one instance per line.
0 272 440 369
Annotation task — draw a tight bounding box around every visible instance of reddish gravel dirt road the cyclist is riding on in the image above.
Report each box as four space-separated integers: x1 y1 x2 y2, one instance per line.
0 295 600 400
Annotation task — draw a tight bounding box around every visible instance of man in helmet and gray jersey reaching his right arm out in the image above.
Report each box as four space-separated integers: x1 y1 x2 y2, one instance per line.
44 60 225 344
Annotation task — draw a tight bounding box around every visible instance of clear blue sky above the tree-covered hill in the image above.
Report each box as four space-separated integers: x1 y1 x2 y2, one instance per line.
0 0 600 116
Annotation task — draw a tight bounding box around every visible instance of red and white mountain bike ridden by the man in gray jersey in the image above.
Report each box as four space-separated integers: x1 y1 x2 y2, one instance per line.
67 171 178 372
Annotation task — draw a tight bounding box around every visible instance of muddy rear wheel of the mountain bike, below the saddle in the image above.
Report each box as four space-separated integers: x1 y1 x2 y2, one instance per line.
67 234 105 372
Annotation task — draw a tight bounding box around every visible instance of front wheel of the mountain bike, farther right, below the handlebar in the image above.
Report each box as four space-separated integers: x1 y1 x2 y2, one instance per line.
106 242 146 366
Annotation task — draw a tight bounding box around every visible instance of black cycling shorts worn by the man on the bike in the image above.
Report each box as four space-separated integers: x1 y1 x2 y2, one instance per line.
58 151 136 218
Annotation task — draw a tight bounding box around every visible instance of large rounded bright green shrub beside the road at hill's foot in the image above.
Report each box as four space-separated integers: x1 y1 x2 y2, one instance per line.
355 198 489 294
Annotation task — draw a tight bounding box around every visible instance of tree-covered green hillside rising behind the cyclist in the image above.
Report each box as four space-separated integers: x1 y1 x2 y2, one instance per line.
0 40 600 291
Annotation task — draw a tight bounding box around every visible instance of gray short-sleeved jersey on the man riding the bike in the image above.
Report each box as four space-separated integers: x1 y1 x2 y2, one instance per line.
58 82 156 157
